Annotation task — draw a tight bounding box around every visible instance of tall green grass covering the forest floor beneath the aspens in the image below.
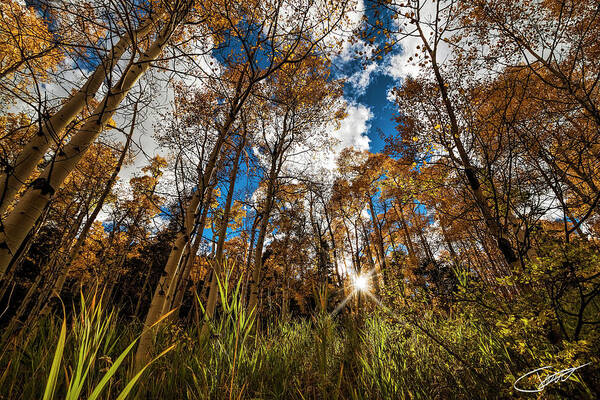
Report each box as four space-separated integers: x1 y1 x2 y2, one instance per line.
0 272 592 400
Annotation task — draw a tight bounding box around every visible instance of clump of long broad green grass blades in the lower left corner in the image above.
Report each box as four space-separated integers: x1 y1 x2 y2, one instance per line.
0 292 173 400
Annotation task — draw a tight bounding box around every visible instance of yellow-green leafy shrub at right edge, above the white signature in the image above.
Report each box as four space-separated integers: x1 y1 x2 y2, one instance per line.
454 236 600 398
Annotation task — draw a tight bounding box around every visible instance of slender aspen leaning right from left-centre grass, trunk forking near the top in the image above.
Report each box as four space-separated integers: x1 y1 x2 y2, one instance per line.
135 1 347 368
